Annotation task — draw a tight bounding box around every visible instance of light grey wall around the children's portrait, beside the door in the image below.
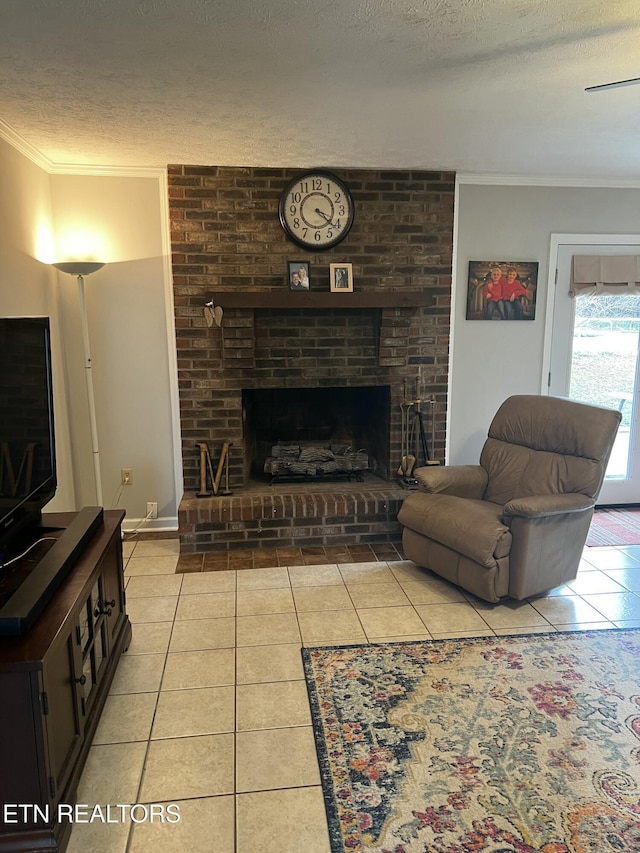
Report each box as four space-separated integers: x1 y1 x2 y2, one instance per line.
448 177 640 464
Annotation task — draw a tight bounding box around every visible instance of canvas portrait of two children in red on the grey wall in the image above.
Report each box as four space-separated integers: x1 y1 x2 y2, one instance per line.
467 261 538 320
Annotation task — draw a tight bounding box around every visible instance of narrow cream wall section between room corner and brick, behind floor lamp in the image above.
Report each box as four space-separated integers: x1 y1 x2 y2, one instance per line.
51 173 182 529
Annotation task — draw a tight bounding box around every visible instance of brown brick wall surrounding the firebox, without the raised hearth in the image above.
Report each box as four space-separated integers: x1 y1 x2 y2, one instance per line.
169 166 454 492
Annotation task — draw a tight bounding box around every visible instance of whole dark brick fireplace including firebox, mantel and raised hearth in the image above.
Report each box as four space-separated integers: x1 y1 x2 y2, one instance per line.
169 166 454 553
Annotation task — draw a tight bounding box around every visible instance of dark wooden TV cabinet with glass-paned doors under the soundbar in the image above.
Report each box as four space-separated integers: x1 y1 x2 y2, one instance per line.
0 510 131 853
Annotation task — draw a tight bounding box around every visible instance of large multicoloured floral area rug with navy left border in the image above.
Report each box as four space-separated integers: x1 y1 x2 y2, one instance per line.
303 629 640 853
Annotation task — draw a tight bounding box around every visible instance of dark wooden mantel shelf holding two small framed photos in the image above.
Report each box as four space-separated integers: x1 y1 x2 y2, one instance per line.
211 289 434 308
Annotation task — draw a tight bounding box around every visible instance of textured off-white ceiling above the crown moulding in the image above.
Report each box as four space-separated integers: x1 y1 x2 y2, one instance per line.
0 0 640 179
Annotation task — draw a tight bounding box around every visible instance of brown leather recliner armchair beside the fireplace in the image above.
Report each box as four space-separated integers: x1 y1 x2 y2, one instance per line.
398 395 621 602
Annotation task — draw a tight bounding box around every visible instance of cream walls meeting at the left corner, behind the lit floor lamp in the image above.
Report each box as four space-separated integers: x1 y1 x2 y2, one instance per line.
0 131 182 529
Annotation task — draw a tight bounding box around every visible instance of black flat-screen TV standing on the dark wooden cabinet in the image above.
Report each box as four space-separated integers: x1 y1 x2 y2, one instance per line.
0 317 56 560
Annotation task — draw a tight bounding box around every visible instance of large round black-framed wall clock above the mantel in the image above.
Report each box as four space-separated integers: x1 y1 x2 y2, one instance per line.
279 171 353 252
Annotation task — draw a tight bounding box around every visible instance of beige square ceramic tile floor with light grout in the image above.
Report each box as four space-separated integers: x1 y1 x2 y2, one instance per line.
68 540 640 853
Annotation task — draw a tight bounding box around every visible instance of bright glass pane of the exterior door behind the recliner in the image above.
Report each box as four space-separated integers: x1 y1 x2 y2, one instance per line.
569 293 640 480
